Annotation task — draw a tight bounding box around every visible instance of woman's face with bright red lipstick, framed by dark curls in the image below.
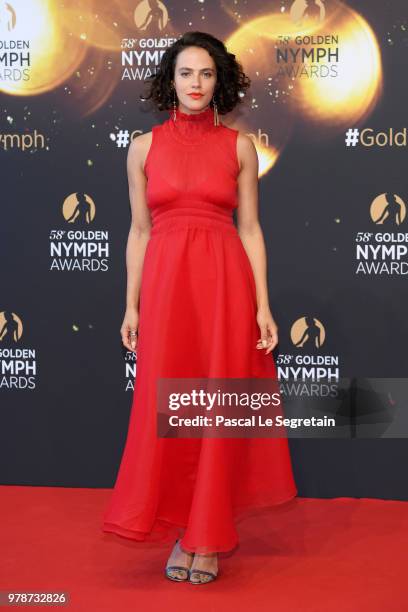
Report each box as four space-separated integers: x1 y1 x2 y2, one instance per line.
174 47 217 113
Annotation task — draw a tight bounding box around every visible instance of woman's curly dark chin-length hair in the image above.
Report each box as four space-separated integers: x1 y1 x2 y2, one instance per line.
140 32 251 115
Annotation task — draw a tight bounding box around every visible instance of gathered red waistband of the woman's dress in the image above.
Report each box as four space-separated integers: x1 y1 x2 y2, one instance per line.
150 202 237 235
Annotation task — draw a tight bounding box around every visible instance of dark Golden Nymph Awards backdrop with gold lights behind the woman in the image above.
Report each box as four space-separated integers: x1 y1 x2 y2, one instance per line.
0 0 408 499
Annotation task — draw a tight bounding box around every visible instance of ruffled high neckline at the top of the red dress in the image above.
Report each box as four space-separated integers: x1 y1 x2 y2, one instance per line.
167 106 219 144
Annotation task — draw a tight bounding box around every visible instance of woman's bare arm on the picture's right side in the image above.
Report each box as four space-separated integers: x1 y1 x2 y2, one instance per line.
237 133 278 353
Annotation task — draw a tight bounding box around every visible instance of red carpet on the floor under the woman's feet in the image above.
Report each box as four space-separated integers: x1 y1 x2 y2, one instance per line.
0 486 408 612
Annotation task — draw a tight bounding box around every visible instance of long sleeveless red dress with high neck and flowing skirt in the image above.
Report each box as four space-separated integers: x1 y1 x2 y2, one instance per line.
102 107 297 554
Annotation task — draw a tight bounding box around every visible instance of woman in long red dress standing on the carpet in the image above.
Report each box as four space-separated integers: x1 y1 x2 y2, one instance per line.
103 32 297 584
